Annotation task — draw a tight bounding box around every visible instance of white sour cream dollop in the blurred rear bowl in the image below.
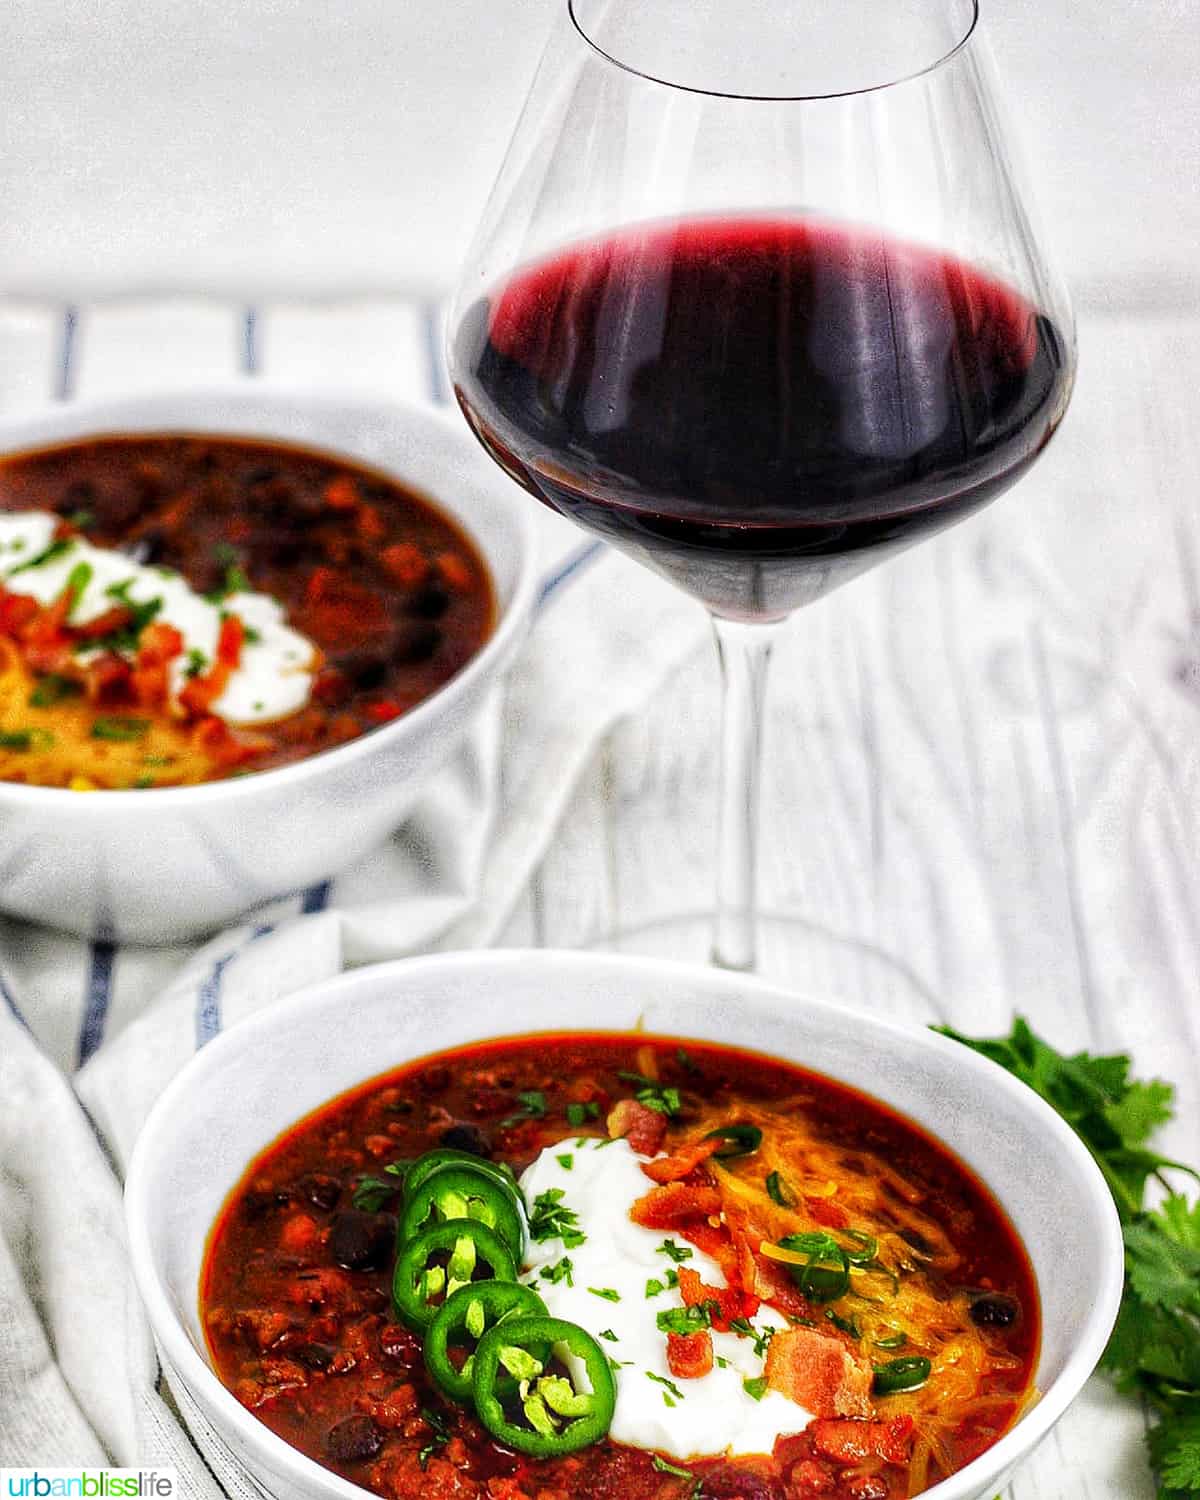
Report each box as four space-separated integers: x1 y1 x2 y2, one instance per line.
0 510 317 725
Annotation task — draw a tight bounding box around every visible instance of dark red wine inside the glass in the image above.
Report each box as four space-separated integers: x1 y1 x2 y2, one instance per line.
453 219 1070 618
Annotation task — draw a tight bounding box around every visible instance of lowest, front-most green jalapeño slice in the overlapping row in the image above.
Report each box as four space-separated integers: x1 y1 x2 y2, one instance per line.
471 1316 617 1458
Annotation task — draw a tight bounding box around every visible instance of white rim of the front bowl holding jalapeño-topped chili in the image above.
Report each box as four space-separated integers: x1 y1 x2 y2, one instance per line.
125 948 1125 1500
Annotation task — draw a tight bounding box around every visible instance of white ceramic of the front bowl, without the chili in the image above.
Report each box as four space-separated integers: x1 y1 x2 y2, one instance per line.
126 951 1124 1500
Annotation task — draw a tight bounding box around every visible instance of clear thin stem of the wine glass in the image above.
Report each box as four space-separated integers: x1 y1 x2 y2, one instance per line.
713 615 779 969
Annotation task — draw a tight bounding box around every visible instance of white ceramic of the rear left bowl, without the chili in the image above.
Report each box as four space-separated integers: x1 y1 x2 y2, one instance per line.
0 383 536 942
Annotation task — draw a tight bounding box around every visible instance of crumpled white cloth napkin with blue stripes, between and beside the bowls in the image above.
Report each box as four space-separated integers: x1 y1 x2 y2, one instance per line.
0 534 707 1482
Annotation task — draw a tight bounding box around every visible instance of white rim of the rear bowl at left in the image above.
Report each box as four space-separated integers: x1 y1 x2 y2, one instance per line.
0 375 537 818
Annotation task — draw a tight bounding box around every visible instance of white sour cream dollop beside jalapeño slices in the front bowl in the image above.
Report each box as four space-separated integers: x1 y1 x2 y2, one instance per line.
521 1139 813 1458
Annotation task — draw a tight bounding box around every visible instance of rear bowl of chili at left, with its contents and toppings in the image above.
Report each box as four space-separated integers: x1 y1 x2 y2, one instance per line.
0 383 536 944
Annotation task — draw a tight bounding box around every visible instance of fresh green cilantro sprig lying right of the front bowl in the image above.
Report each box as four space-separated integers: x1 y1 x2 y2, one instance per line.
939 1019 1200 1500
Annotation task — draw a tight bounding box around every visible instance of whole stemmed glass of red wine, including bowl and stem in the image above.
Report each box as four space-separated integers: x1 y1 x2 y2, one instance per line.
449 0 1076 969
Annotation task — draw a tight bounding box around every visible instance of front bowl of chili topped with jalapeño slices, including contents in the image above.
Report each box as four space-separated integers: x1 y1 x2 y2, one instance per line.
126 951 1124 1500
